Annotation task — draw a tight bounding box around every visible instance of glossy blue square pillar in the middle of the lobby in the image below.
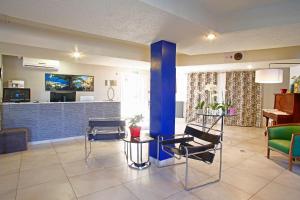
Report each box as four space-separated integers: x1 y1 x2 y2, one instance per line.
150 40 176 161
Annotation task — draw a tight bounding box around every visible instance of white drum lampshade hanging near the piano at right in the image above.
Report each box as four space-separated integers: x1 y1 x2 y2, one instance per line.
255 63 283 83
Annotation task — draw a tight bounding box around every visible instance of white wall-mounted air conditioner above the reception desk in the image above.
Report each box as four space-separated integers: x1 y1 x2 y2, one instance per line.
23 57 60 71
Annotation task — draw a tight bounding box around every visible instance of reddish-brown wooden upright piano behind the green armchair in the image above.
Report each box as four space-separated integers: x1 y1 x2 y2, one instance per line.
263 93 300 126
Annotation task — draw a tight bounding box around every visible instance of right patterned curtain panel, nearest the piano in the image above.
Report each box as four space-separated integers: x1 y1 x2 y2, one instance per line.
225 71 262 127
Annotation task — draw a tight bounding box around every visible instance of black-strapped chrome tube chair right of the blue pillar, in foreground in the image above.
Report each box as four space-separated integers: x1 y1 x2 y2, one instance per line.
157 126 223 190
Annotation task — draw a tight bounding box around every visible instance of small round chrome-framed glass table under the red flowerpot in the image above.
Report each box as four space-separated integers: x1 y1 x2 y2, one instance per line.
123 133 154 170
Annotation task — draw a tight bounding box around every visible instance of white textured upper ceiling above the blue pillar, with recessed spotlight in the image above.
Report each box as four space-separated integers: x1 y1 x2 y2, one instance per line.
0 0 300 55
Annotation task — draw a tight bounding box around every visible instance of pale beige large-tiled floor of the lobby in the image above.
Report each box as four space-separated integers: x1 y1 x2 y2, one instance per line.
0 120 300 200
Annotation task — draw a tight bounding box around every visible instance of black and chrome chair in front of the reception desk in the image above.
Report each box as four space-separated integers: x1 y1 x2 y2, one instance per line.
85 118 126 160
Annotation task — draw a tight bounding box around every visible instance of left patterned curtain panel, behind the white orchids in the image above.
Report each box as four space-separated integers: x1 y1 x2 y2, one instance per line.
186 72 217 122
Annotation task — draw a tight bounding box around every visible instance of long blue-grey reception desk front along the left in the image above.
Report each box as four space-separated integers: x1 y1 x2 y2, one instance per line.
1 102 121 141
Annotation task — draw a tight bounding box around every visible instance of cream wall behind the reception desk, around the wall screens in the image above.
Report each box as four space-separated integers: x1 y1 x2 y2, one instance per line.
3 56 149 102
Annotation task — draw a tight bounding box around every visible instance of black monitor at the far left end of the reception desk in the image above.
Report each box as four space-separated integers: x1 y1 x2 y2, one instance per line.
3 88 30 103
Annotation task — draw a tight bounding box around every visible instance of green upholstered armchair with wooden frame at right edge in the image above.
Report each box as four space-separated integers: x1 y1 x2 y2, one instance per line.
267 124 300 171
